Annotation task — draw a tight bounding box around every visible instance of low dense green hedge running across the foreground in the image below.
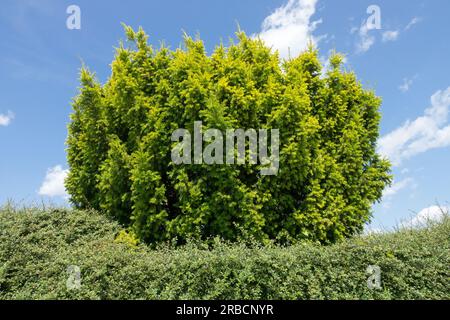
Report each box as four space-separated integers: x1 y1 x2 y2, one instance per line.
0 208 450 299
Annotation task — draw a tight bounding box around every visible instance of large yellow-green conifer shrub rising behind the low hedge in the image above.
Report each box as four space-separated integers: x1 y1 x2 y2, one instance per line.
66 27 390 242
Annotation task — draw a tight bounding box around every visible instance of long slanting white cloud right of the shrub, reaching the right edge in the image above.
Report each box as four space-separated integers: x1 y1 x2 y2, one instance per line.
378 87 450 166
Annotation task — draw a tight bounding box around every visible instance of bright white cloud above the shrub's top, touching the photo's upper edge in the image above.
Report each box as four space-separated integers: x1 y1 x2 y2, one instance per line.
254 0 322 58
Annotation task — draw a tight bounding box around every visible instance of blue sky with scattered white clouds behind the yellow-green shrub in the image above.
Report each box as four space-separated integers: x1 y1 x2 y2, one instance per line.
0 0 450 230
